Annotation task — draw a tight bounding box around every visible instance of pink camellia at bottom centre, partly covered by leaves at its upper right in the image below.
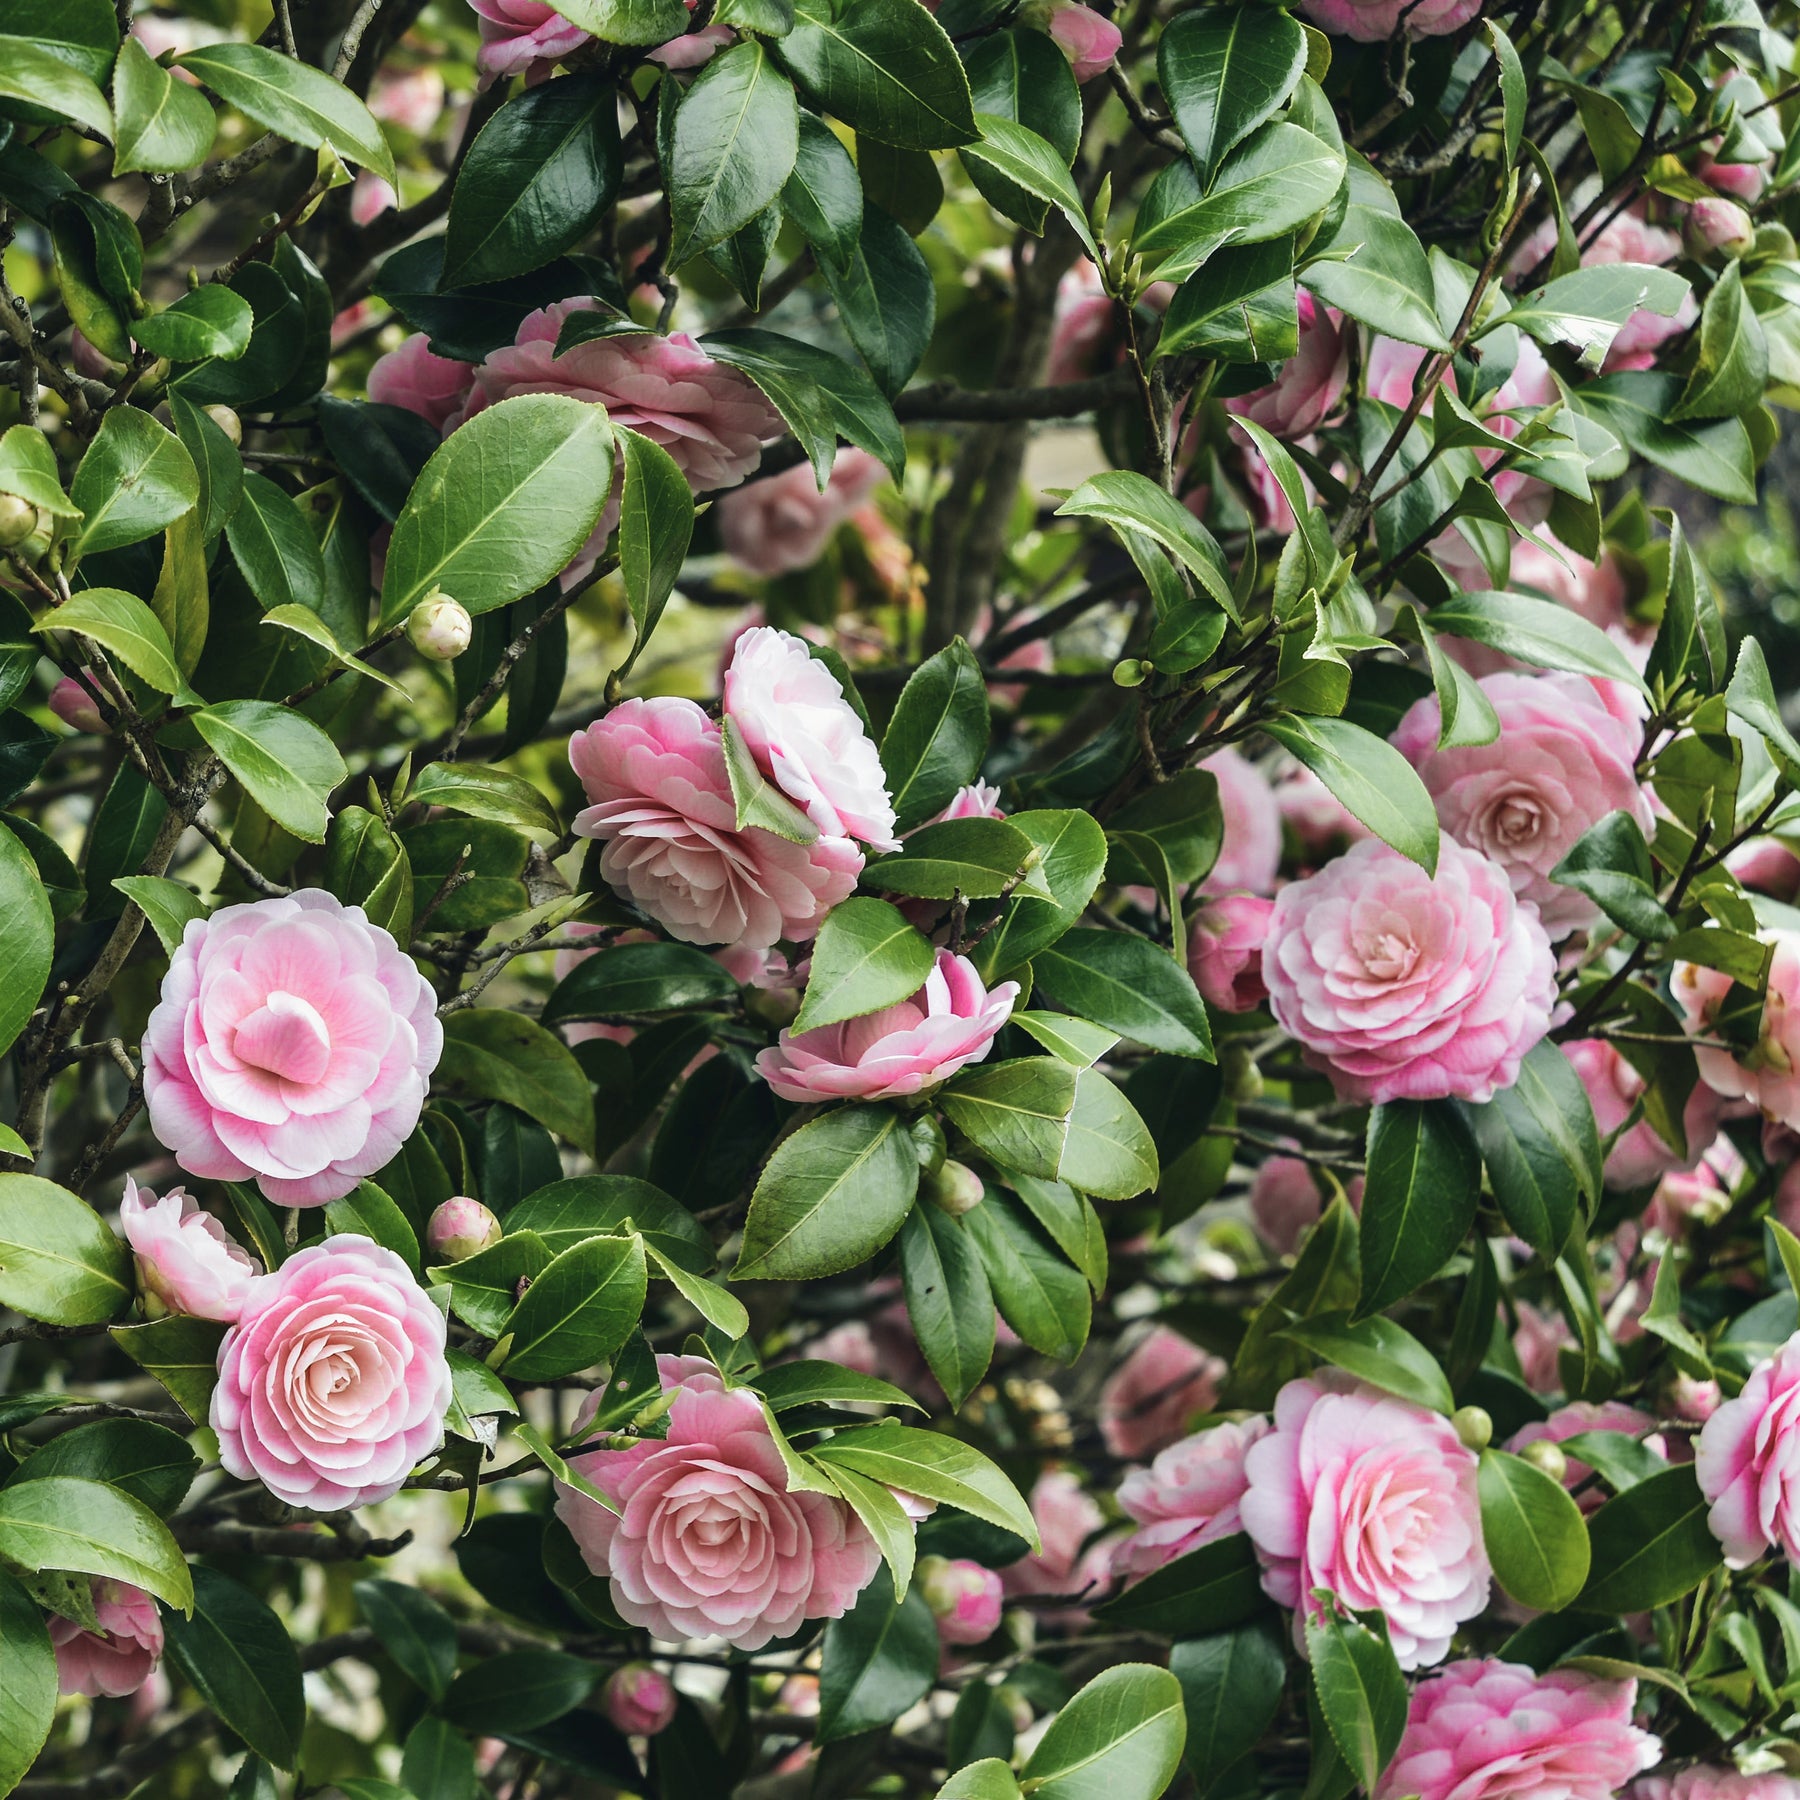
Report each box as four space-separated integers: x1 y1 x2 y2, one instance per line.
556 1355 882 1651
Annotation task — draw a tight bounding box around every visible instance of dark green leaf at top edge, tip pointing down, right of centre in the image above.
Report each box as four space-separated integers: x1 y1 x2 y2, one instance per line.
1156 5 1307 182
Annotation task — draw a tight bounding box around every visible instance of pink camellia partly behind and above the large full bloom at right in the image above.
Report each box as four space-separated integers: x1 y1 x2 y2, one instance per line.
1393 675 1654 941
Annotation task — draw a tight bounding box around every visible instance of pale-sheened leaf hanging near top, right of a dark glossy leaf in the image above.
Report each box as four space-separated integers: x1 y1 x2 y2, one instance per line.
664 38 799 268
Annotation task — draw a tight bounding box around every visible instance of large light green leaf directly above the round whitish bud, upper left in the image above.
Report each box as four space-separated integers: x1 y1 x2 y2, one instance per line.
382 394 612 628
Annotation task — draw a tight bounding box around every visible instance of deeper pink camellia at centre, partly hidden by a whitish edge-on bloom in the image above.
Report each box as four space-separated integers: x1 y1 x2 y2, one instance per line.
569 695 862 950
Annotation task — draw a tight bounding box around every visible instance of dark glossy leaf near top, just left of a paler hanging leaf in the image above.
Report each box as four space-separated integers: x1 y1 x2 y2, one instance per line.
439 72 625 288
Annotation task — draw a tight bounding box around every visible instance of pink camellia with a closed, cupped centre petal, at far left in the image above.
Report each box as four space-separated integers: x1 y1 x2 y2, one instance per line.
144 887 445 1206
